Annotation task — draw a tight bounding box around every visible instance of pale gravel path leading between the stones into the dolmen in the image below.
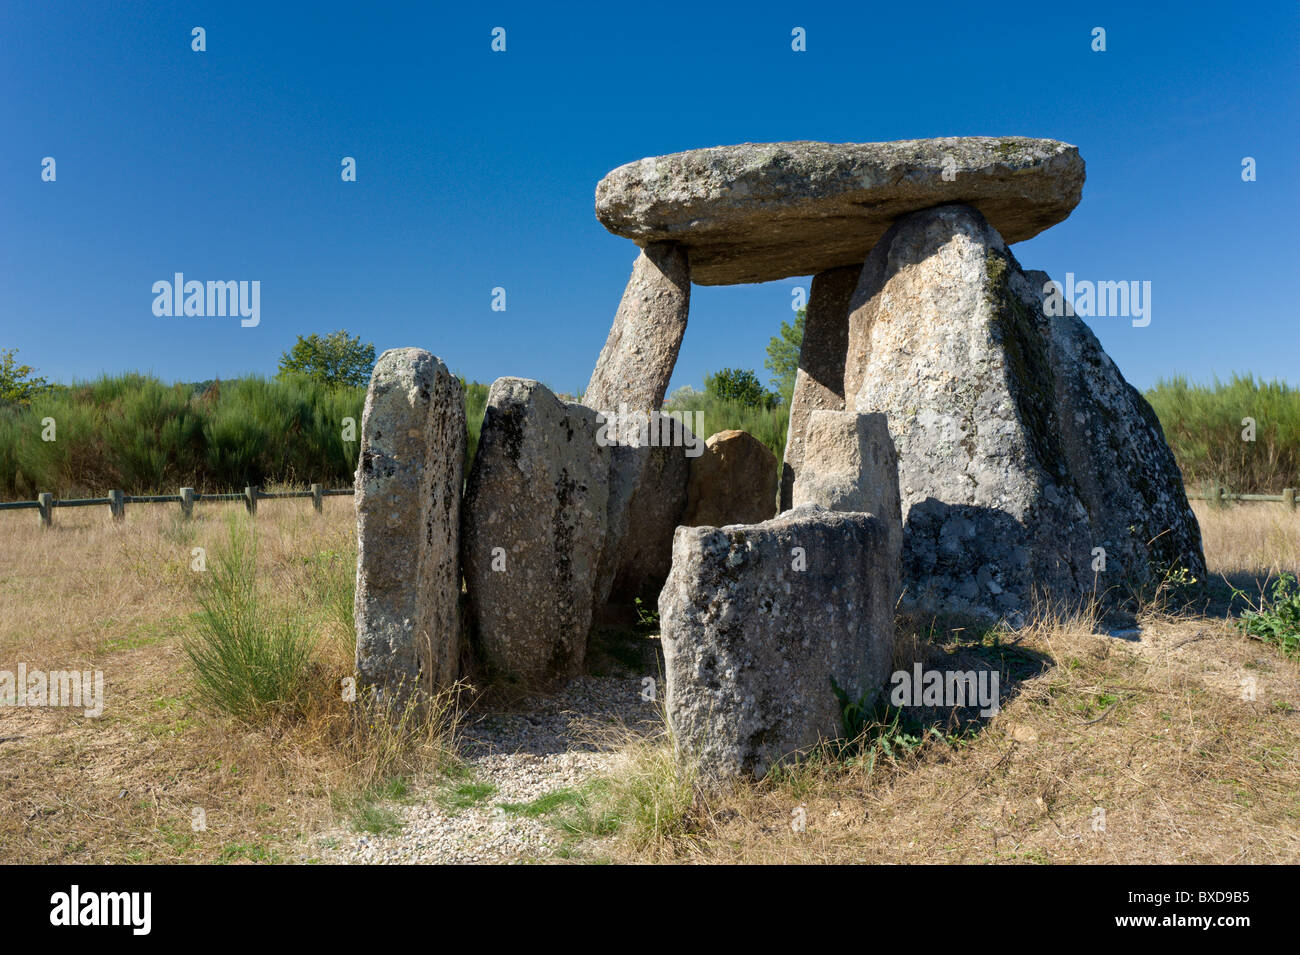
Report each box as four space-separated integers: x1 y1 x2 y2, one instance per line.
313 677 660 864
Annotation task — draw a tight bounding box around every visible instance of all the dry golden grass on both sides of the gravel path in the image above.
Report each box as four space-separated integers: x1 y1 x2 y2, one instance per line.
0 498 1300 863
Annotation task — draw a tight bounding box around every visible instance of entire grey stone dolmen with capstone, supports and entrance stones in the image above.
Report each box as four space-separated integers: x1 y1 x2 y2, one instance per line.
356 136 1205 783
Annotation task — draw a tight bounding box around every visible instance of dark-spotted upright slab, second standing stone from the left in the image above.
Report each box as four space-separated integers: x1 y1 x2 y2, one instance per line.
462 378 610 685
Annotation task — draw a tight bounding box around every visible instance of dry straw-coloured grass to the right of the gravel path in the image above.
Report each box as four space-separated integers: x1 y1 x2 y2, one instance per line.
587 505 1300 864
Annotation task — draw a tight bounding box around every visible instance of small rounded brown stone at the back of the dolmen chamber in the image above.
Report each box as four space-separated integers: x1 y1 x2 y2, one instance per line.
681 431 777 528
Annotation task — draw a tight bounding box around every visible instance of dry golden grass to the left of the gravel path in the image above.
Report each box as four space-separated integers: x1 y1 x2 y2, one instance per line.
0 498 450 863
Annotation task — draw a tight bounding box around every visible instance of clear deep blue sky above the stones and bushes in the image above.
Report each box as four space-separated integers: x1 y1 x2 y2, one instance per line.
0 1 1300 391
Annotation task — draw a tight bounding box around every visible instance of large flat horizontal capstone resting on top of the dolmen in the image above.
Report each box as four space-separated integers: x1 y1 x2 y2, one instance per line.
595 136 1084 285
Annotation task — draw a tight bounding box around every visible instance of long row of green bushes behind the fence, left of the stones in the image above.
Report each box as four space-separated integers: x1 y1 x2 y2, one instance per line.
0 374 365 499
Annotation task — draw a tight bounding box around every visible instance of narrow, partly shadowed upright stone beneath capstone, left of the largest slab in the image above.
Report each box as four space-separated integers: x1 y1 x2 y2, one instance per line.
780 265 862 511
